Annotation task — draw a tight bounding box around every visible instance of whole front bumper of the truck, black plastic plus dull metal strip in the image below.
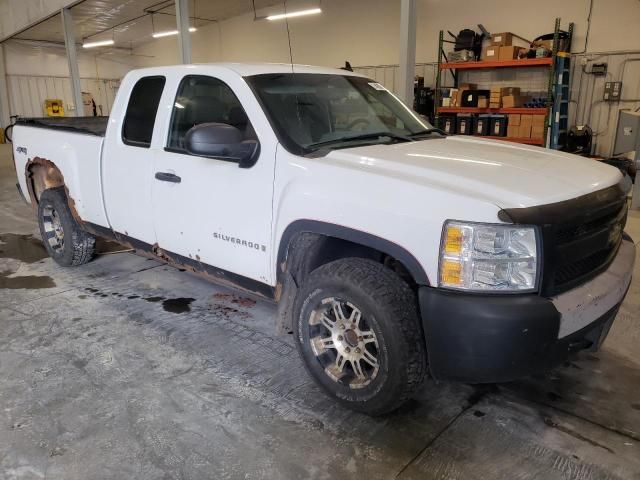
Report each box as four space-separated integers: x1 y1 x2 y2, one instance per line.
419 237 635 383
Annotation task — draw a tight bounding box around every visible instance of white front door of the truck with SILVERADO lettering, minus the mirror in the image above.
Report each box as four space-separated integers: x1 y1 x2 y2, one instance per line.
152 72 276 285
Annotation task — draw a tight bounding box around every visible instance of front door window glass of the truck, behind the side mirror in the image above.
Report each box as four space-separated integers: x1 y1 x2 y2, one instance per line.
167 75 257 153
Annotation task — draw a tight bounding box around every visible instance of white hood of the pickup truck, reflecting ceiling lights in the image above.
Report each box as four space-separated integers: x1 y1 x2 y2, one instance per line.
321 136 622 208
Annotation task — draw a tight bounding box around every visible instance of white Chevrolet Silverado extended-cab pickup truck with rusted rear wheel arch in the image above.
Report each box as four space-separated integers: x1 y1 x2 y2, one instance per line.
14 64 635 414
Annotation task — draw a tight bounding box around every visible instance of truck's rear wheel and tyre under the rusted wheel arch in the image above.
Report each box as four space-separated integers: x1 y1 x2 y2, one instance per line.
38 187 96 267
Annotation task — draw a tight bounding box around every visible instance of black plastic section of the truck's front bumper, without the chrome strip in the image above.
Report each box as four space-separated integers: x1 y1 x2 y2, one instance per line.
419 287 620 383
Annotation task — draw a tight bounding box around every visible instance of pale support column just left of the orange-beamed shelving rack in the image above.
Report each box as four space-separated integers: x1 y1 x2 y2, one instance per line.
398 0 416 108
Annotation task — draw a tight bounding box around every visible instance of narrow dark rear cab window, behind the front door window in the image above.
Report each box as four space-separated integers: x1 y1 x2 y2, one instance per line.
122 76 166 148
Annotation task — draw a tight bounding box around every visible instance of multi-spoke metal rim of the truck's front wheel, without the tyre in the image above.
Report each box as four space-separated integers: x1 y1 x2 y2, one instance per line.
309 297 380 389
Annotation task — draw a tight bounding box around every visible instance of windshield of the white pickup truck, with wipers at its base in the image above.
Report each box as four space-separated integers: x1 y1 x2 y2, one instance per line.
247 73 433 154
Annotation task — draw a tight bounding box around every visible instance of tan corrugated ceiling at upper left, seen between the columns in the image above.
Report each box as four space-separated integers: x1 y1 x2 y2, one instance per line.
13 0 282 48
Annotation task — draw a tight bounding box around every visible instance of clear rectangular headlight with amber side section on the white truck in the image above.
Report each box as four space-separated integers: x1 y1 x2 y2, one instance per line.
439 220 538 292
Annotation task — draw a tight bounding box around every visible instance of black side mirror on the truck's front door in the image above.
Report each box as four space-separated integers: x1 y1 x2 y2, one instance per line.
184 123 259 168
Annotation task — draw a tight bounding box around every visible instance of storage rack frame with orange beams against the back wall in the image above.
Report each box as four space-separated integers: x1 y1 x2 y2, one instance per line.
434 18 573 150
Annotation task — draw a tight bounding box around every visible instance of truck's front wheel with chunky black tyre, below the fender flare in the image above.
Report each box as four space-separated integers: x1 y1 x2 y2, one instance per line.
293 258 426 415
